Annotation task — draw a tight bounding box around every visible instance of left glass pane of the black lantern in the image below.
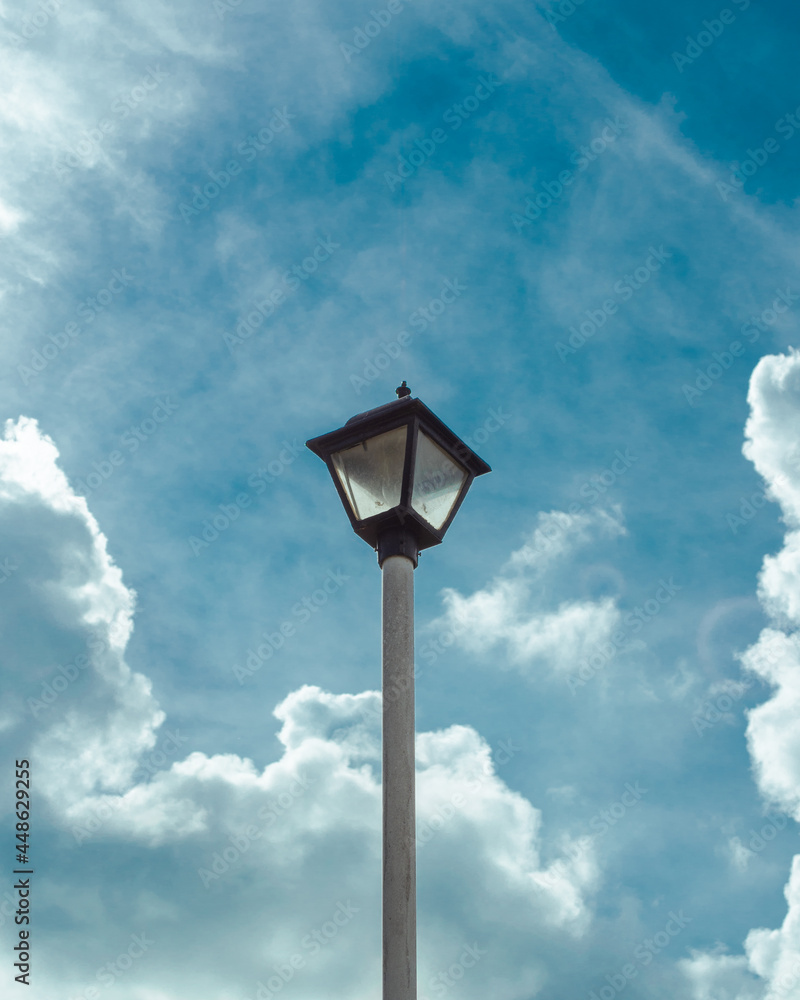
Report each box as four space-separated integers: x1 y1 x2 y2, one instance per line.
331 425 408 521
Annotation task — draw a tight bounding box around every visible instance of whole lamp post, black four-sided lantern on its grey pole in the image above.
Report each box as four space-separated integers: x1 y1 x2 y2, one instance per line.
306 382 491 1000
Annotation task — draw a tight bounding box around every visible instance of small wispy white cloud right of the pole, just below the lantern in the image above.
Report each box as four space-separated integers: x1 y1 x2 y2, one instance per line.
424 510 624 673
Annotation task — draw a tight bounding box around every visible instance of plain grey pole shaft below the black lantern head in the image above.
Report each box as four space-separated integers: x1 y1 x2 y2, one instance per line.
382 556 417 1000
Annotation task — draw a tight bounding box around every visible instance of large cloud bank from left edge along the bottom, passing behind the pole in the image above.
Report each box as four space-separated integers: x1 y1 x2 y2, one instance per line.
0 417 599 1000
